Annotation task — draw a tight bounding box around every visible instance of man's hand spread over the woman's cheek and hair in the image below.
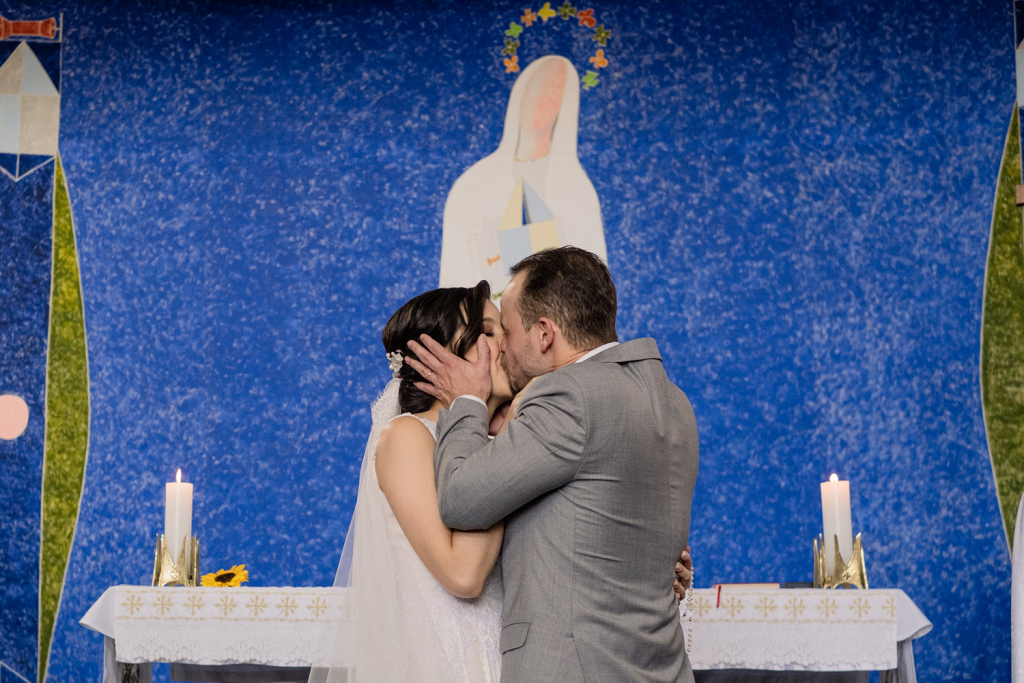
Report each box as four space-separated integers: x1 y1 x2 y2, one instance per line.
406 335 490 408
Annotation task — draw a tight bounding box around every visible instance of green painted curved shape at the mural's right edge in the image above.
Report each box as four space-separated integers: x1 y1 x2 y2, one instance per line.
981 105 1024 548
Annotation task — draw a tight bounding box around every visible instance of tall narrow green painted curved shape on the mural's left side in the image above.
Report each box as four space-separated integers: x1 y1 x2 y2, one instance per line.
39 157 89 683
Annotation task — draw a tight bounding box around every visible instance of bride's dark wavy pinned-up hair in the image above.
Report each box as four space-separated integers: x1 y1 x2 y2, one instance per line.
381 280 490 413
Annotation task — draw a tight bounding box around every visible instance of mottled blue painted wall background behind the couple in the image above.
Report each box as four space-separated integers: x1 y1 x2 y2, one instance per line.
0 0 1014 681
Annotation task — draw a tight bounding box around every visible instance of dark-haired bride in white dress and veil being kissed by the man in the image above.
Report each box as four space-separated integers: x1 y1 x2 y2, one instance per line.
309 281 690 683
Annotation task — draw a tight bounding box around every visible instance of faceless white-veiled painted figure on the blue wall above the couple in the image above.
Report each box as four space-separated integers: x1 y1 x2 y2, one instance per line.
440 55 607 299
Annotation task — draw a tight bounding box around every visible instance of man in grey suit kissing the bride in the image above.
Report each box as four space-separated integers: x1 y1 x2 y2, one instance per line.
409 247 697 683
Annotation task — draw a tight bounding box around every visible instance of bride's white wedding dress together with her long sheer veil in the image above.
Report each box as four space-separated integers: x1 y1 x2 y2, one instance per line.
309 380 503 683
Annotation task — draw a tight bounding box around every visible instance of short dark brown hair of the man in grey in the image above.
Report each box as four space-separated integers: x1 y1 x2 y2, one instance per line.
512 247 618 349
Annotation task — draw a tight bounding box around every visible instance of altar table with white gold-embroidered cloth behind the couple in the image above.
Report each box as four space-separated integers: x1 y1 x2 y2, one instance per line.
81 586 932 683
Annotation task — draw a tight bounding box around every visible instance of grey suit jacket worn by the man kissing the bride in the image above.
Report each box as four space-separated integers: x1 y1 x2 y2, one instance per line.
434 339 697 683
